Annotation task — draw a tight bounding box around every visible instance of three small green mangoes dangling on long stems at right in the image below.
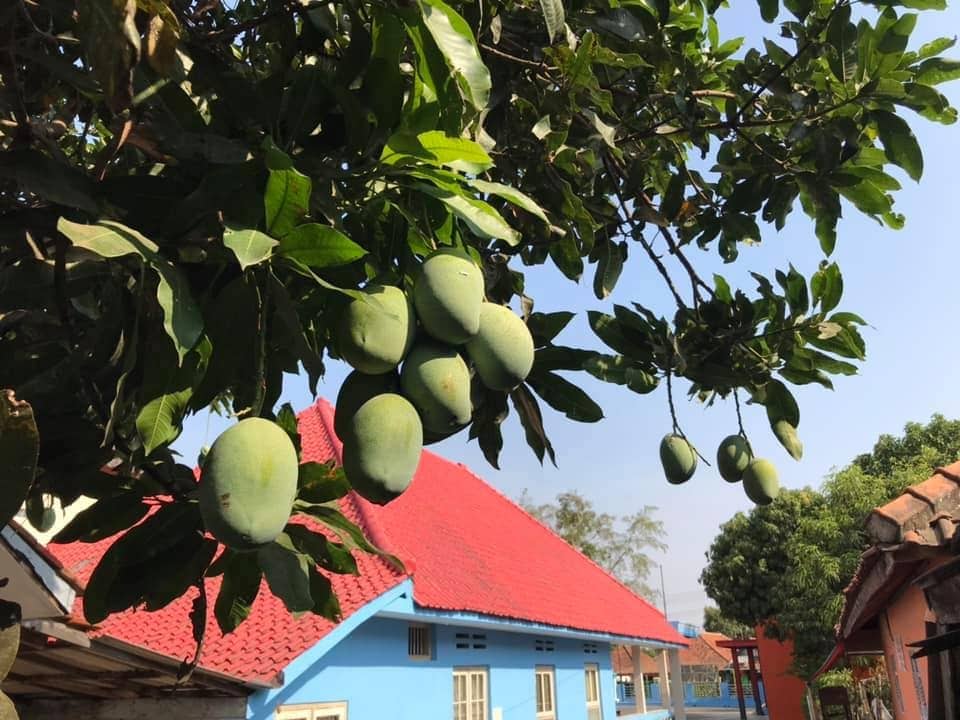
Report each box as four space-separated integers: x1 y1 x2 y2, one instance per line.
660 433 780 505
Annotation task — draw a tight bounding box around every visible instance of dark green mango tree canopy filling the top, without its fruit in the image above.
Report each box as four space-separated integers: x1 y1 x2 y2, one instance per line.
0 0 960 637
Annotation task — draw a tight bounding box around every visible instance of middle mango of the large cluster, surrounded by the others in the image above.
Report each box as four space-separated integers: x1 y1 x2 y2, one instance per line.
400 340 473 435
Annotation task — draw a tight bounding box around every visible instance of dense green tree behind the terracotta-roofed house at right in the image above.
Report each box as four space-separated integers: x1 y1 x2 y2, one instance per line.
700 415 960 677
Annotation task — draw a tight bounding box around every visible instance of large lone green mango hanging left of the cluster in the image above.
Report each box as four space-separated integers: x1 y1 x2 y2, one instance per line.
199 418 299 550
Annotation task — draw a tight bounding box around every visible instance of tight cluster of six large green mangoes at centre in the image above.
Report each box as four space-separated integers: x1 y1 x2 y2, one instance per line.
334 249 534 504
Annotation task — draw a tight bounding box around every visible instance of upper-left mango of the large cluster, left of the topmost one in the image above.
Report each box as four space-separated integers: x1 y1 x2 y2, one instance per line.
337 285 416 375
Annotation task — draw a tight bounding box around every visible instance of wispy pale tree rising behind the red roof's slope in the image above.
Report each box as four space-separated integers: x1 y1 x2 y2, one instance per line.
520 490 667 601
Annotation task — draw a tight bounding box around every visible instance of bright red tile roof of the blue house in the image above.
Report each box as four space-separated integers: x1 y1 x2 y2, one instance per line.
50 400 686 680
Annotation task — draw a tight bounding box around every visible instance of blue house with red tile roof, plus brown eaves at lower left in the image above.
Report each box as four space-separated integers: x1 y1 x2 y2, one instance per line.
3 400 686 720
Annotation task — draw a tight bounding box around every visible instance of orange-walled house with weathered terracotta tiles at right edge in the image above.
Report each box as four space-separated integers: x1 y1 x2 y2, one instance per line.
818 462 960 720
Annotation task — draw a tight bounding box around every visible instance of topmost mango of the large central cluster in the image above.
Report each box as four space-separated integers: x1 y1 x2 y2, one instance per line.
413 249 484 345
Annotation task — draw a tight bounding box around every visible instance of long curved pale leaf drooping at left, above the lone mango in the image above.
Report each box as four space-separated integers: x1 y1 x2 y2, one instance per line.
57 218 203 362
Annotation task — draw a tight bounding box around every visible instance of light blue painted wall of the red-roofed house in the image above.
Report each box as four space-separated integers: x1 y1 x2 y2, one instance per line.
248 617 616 720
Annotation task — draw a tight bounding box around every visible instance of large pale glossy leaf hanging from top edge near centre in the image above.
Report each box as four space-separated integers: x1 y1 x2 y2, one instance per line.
418 0 491 111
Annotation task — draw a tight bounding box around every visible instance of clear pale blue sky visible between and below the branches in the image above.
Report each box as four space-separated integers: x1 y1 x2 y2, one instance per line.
176 0 960 624
